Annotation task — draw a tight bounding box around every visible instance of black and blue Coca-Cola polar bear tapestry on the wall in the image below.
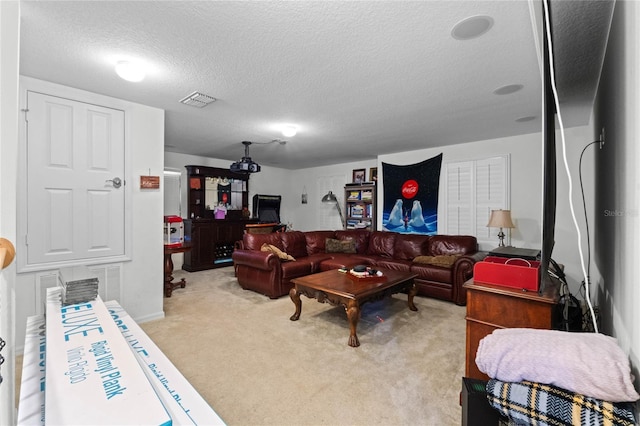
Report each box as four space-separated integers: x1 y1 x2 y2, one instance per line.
382 154 442 235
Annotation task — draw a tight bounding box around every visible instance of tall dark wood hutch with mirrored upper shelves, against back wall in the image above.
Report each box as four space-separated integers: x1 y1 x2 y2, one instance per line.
182 165 255 272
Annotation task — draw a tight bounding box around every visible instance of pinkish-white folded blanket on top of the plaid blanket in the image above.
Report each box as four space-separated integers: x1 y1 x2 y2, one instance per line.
476 328 640 402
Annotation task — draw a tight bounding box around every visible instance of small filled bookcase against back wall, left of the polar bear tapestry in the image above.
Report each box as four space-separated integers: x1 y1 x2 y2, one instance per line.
344 182 377 231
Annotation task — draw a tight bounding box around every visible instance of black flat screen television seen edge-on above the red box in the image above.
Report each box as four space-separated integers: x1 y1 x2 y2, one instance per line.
538 0 557 293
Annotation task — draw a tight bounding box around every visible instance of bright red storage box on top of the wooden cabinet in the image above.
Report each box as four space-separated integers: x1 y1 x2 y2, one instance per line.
473 256 540 291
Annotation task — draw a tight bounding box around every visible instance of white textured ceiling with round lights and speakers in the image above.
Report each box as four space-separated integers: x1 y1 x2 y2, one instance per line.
20 0 613 169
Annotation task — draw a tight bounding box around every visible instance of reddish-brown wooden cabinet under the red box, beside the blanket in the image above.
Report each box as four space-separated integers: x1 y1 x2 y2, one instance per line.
464 279 559 380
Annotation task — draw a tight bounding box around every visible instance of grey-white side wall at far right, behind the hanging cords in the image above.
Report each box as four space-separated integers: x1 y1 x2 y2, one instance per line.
593 1 640 380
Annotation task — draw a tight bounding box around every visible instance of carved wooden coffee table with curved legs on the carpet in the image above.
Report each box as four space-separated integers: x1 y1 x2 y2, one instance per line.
289 269 418 347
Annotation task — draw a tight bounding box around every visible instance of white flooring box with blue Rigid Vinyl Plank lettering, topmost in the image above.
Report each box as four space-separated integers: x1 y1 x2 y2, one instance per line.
45 288 171 426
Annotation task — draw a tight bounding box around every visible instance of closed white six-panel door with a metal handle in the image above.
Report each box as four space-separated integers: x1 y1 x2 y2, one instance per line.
26 91 125 265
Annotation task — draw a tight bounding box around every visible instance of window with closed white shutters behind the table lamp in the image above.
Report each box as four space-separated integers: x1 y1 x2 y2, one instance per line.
440 155 510 245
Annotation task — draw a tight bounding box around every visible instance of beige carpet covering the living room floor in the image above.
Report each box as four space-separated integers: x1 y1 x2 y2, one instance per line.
141 267 466 425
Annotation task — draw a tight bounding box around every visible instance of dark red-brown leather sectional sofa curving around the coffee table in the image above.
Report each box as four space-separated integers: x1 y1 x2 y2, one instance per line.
232 230 486 305
